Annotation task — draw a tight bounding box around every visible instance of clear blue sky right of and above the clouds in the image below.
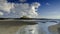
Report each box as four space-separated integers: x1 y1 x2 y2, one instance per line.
0 0 60 19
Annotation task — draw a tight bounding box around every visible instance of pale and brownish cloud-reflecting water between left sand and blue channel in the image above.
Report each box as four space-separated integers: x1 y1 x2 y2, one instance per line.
17 25 38 34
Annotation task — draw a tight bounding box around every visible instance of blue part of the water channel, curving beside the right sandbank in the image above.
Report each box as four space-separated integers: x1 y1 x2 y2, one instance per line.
39 22 58 34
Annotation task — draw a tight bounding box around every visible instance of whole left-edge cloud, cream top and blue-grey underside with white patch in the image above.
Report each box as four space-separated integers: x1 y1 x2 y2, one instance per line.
0 0 14 17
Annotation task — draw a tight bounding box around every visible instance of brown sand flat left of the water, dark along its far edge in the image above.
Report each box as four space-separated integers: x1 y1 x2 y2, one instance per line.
0 20 37 34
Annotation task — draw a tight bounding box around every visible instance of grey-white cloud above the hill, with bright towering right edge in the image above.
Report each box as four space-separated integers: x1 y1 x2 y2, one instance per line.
9 3 40 18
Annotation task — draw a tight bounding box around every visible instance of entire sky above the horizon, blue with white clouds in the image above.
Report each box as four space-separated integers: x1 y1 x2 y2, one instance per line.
0 0 60 19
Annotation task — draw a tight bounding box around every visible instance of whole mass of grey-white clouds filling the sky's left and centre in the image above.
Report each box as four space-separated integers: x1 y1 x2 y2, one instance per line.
0 0 40 18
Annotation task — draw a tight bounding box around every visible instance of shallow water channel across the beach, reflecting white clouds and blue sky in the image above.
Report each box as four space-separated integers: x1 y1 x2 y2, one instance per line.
17 22 58 34
